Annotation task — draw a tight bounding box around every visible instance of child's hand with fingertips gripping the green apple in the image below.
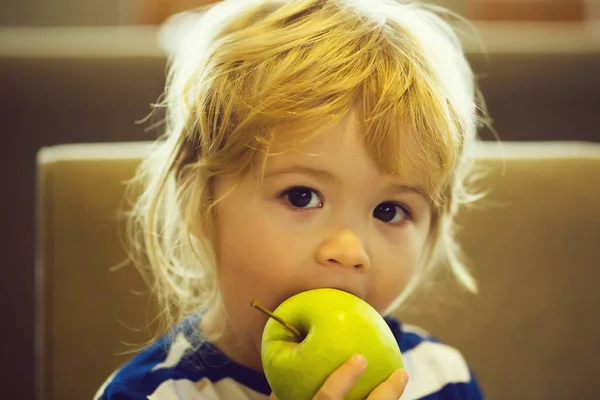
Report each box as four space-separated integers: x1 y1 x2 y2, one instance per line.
269 357 408 400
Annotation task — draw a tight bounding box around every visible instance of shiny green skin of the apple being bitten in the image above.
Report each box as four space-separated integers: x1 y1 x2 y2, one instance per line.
261 288 404 400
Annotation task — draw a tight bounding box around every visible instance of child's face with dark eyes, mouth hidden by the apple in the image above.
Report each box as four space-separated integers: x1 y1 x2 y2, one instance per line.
206 108 431 368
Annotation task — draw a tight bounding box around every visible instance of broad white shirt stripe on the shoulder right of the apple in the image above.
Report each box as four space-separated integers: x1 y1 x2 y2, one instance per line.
402 341 471 400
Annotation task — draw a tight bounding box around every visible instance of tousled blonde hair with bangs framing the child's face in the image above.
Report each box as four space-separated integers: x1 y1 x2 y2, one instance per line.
129 0 482 338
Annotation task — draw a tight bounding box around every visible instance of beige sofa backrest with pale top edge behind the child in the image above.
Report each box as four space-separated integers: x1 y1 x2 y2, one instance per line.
36 142 600 400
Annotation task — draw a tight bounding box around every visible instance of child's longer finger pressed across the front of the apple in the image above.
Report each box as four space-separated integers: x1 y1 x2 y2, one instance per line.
314 354 367 400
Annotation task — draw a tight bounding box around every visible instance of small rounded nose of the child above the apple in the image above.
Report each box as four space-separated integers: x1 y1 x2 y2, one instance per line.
317 229 370 270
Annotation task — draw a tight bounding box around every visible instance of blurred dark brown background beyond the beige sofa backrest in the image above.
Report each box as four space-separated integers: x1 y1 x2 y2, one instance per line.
0 0 600 399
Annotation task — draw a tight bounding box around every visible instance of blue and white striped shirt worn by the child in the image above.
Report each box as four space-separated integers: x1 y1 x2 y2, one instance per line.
95 317 483 400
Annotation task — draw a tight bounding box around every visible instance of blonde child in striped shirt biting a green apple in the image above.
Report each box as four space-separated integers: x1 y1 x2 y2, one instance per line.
96 0 482 400
